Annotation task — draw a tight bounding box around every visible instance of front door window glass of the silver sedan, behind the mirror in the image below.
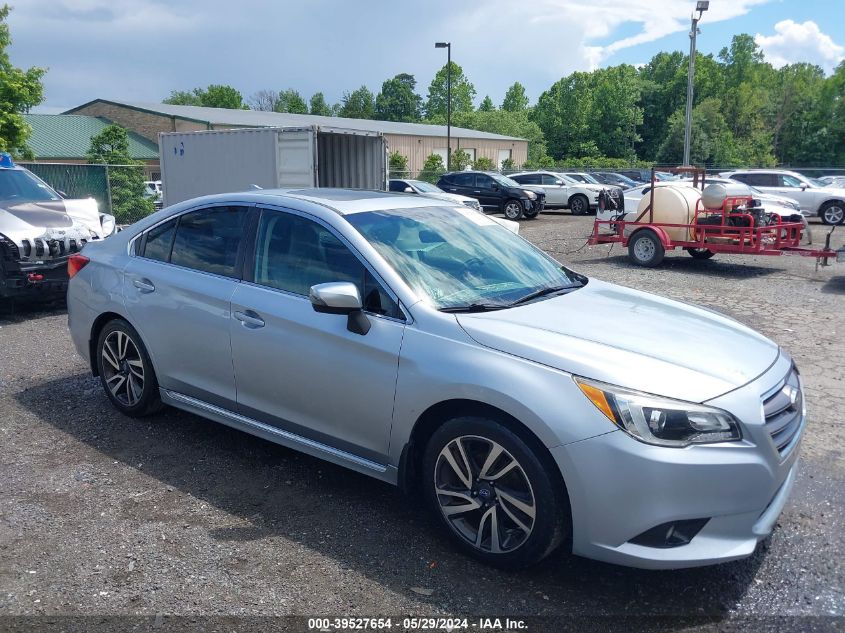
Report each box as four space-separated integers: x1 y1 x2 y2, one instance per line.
253 210 400 318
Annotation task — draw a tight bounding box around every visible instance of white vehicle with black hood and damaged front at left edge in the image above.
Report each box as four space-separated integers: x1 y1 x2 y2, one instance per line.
0 153 115 299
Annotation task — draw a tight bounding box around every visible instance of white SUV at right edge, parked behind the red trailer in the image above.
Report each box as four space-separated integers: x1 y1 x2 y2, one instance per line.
720 169 845 224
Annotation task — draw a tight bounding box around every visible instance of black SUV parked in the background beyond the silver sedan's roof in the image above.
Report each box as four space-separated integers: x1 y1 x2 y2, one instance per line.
437 171 546 220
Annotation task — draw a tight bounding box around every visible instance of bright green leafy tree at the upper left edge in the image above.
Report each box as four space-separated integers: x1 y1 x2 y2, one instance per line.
0 4 47 158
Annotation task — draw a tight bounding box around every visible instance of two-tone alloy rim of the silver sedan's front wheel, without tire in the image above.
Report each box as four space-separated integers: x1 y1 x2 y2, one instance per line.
434 435 537 554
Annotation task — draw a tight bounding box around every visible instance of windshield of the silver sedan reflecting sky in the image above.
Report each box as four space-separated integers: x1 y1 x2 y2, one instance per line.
346 207 586 310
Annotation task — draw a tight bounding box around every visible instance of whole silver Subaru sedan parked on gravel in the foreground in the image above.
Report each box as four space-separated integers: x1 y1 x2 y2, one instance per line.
68 189 806 568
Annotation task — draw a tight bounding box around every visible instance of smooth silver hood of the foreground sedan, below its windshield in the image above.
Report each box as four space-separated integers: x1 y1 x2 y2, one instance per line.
456 279 779 402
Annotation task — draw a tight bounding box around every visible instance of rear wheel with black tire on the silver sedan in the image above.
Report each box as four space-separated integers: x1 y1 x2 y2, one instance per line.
96 319 162 418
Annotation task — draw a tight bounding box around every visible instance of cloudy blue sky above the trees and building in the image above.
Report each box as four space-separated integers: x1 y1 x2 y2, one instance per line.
9 0 845 112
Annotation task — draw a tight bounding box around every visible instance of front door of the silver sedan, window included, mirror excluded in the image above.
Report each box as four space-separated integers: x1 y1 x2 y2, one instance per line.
230 208 405 464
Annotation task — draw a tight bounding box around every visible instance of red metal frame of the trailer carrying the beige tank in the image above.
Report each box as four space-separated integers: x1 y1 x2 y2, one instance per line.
588 167 836 266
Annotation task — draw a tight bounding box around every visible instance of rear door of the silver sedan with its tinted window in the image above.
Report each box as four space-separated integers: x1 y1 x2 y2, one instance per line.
123 205 250 409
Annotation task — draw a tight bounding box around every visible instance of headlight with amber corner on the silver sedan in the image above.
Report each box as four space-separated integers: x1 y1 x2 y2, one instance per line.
575 378 742 448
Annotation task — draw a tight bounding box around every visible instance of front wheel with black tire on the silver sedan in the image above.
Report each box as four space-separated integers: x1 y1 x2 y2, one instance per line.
422 417 570 569
